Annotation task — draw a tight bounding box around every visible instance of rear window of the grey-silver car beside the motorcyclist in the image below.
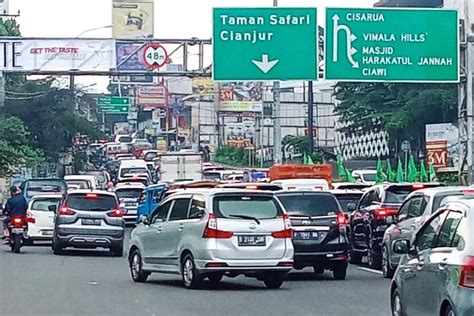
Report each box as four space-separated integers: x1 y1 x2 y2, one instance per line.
66 193 117 212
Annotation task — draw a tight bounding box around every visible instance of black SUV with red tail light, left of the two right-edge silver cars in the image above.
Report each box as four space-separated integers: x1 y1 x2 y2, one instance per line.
348 183 440 269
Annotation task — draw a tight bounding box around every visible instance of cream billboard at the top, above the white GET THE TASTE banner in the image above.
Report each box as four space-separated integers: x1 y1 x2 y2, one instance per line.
112 0 154 38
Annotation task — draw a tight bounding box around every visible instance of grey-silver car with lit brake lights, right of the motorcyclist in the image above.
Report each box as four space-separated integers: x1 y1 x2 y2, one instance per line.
52 190 124 257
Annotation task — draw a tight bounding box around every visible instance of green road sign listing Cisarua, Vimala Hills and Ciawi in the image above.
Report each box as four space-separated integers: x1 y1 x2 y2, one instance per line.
325 8 459 82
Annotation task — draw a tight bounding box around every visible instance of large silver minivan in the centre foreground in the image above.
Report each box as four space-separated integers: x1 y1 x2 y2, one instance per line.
129 189 293 288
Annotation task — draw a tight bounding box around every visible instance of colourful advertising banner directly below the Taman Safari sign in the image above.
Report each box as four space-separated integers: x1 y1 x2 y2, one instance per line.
219 82 263 112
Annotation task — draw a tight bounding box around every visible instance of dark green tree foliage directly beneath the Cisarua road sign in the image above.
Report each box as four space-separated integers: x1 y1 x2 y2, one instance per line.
335 82 457 137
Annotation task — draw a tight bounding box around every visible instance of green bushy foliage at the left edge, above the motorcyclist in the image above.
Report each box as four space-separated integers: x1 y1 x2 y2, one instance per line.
0 117 43 176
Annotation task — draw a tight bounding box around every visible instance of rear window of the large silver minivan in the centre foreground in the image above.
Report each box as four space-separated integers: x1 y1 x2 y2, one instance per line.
213 194 283 219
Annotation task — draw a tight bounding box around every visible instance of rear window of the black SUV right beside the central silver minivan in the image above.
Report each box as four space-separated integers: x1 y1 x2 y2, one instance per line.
278 194 339 216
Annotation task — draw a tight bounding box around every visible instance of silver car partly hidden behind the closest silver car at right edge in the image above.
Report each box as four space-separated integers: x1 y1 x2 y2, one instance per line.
382 186 466 278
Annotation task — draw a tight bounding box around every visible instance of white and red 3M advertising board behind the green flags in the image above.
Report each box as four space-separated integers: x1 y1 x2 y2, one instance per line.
426 123 459 168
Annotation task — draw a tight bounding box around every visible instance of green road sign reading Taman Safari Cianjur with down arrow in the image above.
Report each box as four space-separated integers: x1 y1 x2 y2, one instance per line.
213 8 318 81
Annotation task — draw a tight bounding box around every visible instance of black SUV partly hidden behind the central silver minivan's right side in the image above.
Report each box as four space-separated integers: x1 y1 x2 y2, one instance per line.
275 191 349 280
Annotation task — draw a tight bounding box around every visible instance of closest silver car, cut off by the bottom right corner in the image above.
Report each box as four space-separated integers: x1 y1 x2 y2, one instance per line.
390 200 474 316
